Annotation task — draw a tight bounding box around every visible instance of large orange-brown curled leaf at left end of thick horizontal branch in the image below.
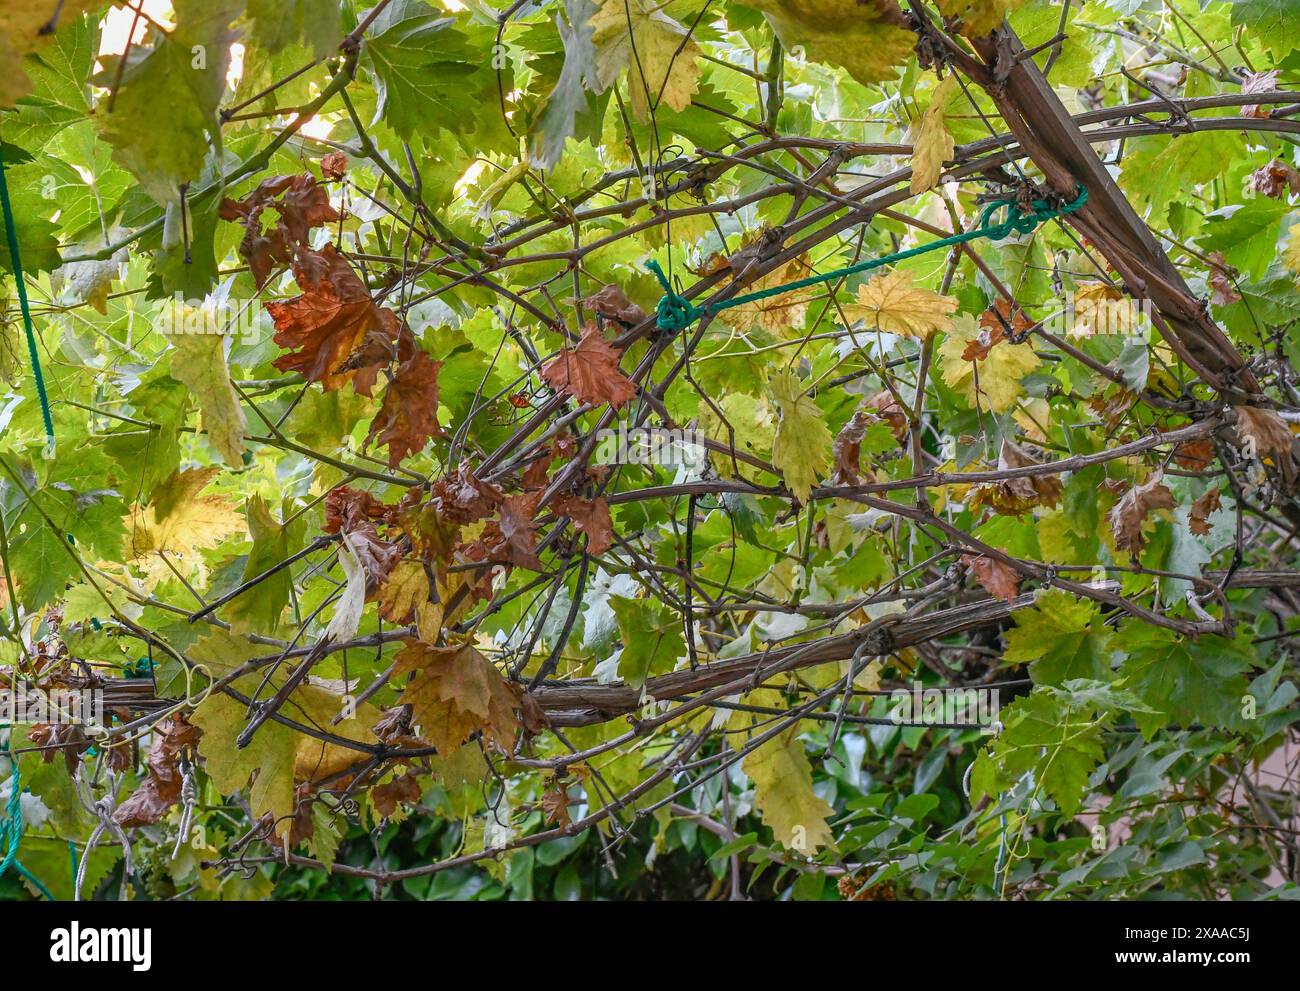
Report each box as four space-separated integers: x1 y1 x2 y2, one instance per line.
394 640 519 753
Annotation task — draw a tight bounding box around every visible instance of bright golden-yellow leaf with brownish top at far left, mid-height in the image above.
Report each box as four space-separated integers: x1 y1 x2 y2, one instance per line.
126 468 244 576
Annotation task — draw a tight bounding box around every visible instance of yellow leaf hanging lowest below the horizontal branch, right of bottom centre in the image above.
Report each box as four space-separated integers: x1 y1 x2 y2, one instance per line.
741 726 835 854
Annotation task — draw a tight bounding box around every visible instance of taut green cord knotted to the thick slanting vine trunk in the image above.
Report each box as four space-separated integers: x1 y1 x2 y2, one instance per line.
646 186 1088 330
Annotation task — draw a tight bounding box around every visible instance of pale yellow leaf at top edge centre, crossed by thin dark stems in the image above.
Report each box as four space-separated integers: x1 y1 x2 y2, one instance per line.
588 0 702 121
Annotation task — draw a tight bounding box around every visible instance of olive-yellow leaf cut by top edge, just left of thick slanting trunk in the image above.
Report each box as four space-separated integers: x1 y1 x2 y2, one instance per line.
745 0 917 86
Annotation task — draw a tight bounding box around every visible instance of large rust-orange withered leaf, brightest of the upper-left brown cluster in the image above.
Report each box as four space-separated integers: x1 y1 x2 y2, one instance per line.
267 244 400 395
